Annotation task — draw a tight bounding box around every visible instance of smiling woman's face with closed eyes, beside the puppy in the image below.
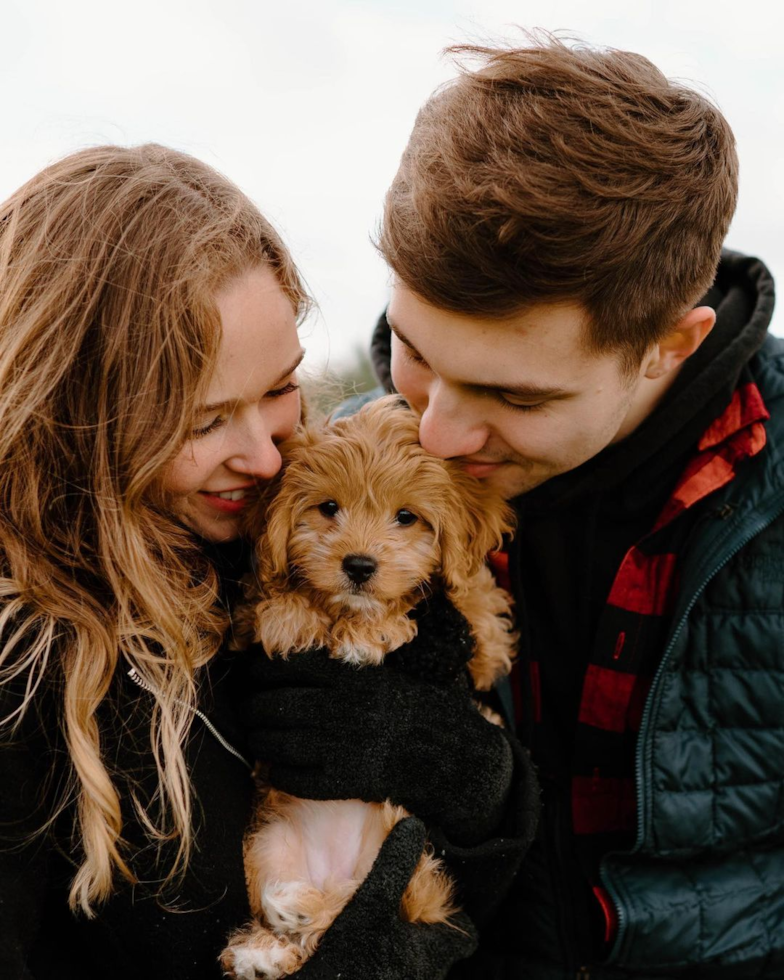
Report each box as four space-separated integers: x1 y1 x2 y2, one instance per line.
163 267 305 542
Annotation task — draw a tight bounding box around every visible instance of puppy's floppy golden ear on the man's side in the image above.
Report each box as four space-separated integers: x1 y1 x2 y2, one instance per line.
439 466 514 595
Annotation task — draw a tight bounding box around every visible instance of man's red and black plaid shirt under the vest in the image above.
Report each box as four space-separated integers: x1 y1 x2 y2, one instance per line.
491 381 769 938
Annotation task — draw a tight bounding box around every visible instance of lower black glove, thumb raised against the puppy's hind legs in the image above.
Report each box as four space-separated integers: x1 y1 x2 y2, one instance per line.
292 817 476 980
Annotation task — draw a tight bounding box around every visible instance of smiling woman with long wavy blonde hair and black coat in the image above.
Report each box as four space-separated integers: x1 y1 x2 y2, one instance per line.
0 145 478 980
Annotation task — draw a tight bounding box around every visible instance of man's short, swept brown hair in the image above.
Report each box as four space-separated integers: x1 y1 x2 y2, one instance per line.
379 35 738 367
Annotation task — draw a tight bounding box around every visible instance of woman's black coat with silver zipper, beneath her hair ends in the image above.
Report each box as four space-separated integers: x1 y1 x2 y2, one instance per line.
0 654 253 980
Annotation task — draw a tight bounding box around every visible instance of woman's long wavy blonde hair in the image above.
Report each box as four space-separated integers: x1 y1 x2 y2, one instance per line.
0 144 306 915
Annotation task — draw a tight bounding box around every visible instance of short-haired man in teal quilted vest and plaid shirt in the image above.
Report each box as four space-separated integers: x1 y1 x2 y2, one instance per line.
242 39 784 980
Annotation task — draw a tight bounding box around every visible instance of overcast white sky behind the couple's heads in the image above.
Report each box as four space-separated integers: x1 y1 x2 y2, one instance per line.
0 0 784 367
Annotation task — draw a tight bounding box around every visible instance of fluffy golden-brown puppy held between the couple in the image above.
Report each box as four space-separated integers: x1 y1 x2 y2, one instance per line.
221 396 516 980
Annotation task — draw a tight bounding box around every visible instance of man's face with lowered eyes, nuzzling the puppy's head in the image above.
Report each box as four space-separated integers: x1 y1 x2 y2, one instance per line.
387 285 652 499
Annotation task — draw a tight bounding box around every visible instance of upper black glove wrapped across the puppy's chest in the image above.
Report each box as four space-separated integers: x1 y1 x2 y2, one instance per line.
241 597 513 844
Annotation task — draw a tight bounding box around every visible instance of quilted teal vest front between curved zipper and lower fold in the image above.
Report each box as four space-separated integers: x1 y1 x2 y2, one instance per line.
643 510 784 857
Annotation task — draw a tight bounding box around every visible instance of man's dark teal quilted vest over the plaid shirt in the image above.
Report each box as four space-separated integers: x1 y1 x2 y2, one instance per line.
602 338 784 980
